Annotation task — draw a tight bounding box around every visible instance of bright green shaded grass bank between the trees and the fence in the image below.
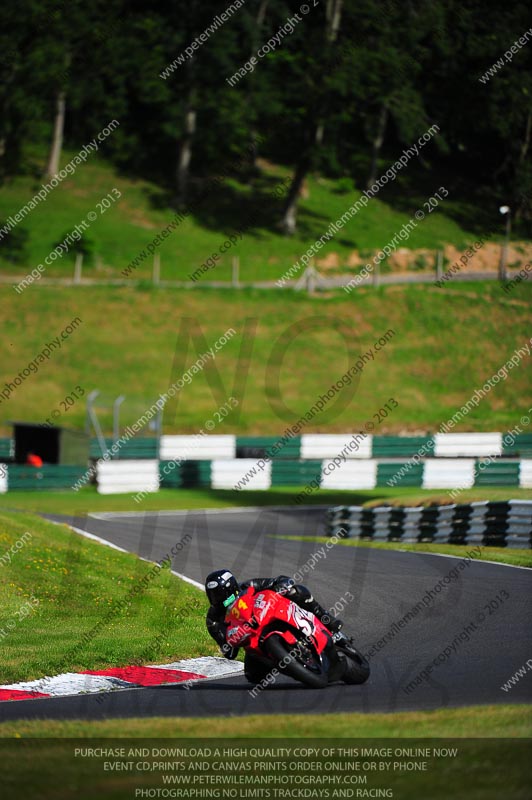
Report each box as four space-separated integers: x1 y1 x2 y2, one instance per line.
0 147 502 281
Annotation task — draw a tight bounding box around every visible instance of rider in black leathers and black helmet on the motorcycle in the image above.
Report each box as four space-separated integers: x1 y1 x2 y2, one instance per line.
205 569 356 683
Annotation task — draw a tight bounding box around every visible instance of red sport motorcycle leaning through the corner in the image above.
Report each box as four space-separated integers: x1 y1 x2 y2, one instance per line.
225 587 369 689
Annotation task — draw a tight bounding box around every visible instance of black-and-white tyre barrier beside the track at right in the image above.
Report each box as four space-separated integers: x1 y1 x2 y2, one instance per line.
325 500 532 548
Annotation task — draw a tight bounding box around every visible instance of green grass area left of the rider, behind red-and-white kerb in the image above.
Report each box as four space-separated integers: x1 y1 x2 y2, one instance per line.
0 512 212 684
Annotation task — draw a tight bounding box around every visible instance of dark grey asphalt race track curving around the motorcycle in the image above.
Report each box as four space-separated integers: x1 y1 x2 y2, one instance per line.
0 508 532 720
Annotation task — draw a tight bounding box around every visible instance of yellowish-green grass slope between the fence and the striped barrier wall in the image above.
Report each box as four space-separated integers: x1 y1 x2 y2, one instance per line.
0 283 532 435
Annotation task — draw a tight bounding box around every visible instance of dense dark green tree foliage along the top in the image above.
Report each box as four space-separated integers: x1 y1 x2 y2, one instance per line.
0 0 532 238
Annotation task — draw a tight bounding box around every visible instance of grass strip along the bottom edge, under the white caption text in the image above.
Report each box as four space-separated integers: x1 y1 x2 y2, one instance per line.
0 706 530 800
